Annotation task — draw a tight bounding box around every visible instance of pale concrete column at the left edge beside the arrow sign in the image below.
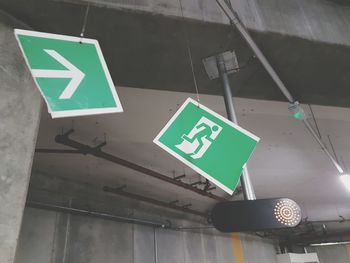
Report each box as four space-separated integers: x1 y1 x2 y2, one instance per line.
0 12 41 263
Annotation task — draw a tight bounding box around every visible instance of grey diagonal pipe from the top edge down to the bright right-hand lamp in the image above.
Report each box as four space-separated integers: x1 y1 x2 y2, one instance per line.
216 0 344 173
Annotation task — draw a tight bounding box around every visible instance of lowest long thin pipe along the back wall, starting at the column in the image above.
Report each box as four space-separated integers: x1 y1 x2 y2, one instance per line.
26 201 167 228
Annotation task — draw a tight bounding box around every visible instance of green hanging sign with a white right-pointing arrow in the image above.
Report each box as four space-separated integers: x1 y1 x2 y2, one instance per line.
15 29 123 118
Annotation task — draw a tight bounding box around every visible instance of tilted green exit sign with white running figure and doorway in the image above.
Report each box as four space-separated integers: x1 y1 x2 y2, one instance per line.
154 98 260 194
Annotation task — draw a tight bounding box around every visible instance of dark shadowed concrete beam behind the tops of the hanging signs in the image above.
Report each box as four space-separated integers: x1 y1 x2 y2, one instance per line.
0 0 350 107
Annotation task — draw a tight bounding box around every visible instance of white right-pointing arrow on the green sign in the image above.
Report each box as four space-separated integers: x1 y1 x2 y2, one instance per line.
32 49 85 99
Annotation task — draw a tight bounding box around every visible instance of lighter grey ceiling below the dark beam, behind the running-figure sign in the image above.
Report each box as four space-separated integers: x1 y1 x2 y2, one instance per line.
33 87 350 220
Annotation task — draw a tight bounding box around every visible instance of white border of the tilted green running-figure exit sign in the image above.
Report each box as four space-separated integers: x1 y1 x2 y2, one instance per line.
153 98 260 195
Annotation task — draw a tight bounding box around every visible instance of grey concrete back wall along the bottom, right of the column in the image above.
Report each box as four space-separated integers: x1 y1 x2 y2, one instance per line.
16 208 276 263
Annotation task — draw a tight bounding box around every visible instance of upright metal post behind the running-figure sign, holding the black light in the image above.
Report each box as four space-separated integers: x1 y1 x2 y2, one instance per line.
216 55 256 200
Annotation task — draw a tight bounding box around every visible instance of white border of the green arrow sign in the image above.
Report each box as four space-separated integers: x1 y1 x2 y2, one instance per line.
14 29 123 118
